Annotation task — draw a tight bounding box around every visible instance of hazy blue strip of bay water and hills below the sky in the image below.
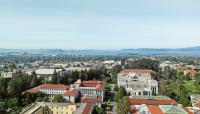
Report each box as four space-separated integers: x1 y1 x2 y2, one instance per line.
0 46 200 56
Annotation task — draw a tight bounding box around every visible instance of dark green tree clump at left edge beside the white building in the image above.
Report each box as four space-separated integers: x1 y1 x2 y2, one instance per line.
0 71 44 114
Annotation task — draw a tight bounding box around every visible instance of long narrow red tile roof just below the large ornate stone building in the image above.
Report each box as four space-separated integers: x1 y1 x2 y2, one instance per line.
128 98 177 105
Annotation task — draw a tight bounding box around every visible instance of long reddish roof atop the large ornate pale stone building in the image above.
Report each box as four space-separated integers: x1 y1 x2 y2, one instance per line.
120 69 156 74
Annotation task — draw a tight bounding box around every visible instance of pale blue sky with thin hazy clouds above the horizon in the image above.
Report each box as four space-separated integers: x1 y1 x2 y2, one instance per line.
0 0 200 50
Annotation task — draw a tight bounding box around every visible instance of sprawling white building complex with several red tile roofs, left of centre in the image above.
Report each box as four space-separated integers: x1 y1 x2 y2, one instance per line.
26 80 105 106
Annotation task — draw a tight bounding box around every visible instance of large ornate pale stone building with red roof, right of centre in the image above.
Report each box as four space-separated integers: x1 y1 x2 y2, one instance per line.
117 69 158 96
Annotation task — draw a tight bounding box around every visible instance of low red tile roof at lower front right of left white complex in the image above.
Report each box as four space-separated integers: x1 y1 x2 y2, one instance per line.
81 96 102 103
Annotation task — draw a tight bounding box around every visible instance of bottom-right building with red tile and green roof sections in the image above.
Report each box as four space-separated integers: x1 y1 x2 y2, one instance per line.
128 96 188 114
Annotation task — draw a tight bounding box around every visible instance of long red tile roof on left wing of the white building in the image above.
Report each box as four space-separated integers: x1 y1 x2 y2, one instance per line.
40 84 69 89
